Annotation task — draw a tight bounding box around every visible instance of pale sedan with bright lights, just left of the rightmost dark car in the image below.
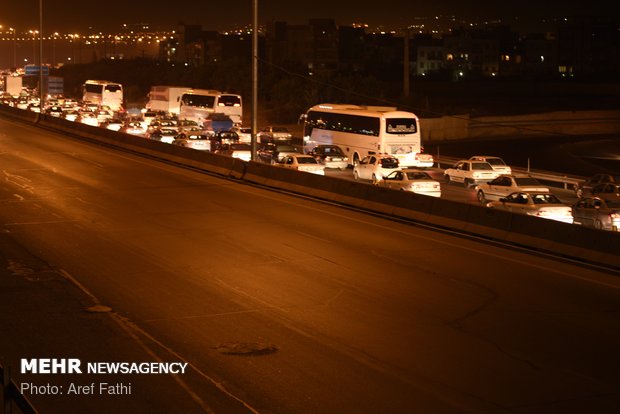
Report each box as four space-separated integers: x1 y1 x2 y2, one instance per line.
487 191 573 223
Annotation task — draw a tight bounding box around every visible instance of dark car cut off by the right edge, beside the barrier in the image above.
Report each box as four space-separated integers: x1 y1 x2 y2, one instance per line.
572 197 620 231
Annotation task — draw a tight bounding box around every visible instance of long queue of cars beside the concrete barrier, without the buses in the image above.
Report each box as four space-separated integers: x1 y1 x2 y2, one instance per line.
2 94 620 232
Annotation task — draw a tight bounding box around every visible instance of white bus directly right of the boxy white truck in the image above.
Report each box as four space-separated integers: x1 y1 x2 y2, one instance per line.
179 89 243 126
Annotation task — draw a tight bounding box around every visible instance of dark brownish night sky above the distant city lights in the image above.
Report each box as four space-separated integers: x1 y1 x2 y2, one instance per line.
0 0 620 32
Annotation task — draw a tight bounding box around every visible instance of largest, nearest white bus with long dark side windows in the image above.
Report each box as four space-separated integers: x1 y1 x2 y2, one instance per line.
302 104 434 167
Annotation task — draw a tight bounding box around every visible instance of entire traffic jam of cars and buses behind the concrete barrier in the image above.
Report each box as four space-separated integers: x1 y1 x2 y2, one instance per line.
1 81 620 232
